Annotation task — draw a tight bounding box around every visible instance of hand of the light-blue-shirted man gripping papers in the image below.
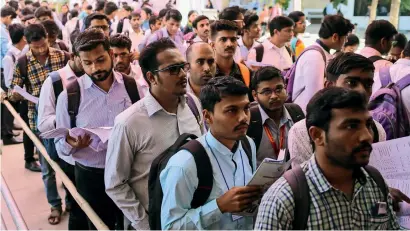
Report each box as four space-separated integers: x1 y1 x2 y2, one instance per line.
216 186 262 213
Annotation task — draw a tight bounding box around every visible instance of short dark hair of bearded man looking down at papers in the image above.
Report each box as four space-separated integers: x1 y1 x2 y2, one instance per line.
74 28 110 55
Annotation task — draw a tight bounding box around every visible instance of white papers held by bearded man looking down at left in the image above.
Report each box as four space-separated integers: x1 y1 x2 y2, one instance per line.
40 127 112 152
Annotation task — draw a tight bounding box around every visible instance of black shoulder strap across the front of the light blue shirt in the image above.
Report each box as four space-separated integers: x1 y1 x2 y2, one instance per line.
181 140 214 208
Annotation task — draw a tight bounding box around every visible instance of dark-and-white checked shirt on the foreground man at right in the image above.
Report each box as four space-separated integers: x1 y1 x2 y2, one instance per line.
255 156 400 230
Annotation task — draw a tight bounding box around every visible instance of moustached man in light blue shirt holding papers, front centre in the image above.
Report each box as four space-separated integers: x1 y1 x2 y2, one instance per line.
160 76 262 230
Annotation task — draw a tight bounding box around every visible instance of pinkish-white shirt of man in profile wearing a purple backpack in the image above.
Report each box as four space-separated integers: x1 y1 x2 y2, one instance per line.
292 43 333 113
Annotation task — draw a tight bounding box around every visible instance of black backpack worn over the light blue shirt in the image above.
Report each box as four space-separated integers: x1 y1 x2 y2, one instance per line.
148 133 254 230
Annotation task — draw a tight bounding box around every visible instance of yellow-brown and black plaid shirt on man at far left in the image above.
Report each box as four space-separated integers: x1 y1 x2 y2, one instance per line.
8 47 66 131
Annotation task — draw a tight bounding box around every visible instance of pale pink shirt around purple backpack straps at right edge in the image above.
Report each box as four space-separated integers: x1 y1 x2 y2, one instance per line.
373 58 410 120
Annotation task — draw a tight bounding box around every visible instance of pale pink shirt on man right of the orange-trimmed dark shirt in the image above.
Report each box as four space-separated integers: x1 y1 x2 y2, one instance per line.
248 39 292 71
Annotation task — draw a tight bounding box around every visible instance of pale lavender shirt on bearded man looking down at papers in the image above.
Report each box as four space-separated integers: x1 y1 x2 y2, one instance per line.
55 72 132 168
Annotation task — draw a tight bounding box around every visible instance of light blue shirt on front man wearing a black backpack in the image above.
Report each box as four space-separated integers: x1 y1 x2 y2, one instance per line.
160 132 256 230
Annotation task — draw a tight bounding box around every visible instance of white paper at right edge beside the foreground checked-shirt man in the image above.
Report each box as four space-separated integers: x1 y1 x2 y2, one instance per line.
369 137 410 180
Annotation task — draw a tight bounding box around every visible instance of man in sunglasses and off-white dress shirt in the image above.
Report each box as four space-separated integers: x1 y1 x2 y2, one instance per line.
105 38 201 230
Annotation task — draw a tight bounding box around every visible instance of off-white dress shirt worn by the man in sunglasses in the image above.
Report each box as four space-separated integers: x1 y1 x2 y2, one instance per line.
104 90 201 230
